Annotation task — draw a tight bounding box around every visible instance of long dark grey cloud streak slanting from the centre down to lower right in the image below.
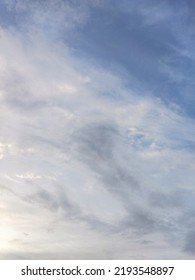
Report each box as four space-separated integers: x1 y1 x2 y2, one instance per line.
70 123 168 237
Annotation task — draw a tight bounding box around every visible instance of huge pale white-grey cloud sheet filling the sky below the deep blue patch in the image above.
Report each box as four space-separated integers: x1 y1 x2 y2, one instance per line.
0 1 195 259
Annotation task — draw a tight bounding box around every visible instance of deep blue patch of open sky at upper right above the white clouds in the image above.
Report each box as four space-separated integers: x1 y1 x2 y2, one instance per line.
66 1 195 117
